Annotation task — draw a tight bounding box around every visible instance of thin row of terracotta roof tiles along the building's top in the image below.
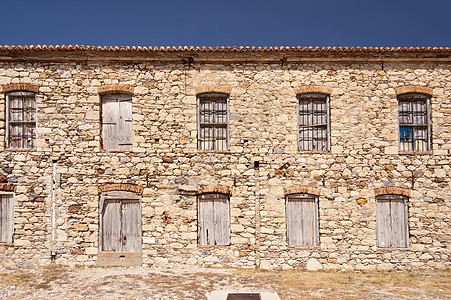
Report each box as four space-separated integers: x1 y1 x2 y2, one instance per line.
0 45 451 53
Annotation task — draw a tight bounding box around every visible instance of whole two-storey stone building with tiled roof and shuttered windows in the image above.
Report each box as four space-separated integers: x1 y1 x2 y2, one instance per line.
0 46 451 269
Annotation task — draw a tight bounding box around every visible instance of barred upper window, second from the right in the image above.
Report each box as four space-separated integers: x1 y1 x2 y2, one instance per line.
298 94 330 152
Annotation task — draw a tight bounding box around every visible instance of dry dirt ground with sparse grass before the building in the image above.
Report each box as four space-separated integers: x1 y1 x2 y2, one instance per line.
0 265 451 299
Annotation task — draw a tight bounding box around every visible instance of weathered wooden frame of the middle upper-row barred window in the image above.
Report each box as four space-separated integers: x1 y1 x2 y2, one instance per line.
196 92 230 152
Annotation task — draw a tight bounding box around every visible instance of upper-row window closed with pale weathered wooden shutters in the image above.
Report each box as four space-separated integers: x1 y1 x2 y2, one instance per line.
102 94 132 150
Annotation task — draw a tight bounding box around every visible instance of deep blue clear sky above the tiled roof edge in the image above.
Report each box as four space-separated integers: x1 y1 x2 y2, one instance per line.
0 0 451 47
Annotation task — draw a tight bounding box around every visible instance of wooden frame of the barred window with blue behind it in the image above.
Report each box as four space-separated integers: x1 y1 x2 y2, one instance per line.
397 93 432 154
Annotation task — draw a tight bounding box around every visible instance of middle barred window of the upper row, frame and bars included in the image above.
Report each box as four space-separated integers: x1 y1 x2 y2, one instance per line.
197 94 229 151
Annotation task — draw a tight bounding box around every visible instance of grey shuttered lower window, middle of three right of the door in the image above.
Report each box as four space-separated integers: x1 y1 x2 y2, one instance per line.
286 194 319 247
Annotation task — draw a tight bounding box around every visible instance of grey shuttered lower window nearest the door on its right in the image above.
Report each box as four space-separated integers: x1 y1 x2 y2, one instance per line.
198 194 230 246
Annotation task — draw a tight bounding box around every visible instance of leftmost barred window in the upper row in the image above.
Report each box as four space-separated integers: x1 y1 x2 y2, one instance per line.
6 91 36 149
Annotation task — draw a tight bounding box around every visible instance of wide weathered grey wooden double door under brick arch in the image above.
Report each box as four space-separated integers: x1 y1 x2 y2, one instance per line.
102 200 141 252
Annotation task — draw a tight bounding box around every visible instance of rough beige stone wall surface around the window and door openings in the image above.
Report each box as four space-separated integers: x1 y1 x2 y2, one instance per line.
0 49 451 269
